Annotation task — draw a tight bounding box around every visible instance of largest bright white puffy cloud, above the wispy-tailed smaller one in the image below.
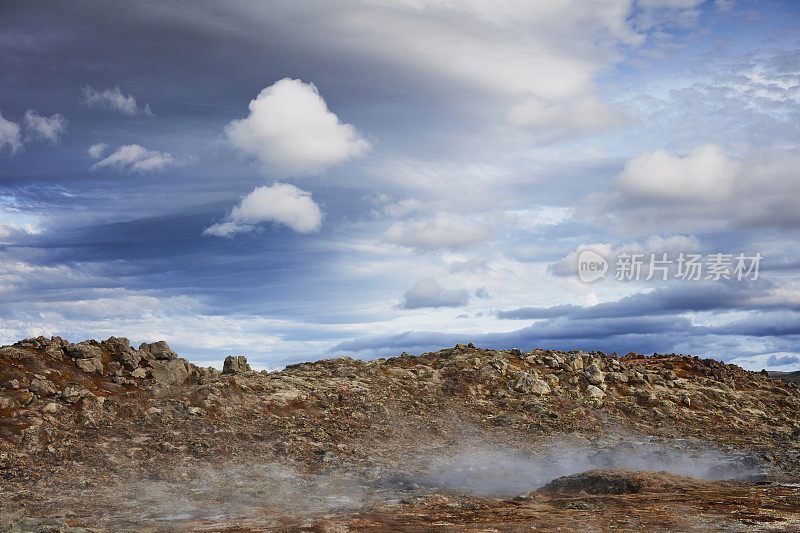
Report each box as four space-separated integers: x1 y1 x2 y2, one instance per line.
225 78 370 174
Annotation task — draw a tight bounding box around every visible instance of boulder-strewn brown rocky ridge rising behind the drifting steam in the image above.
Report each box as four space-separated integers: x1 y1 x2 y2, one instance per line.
0 337 800 523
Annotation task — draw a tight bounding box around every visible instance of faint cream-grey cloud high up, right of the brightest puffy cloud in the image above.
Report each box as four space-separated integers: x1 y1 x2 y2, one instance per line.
508 95 624 138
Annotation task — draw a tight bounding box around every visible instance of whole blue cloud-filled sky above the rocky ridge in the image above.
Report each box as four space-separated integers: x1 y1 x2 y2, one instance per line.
0 0 800 370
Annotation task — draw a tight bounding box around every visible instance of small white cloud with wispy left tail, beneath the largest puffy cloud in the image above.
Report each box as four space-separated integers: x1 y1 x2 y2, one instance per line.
203 183 322 237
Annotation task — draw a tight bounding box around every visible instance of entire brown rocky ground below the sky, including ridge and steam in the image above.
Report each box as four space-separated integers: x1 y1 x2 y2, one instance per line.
0 337 800 531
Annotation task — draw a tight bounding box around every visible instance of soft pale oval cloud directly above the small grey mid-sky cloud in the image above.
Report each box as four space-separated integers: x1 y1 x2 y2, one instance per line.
384 213 490 250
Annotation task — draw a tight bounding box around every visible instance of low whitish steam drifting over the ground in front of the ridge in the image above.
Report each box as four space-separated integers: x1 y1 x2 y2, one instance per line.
21 438 763 530
